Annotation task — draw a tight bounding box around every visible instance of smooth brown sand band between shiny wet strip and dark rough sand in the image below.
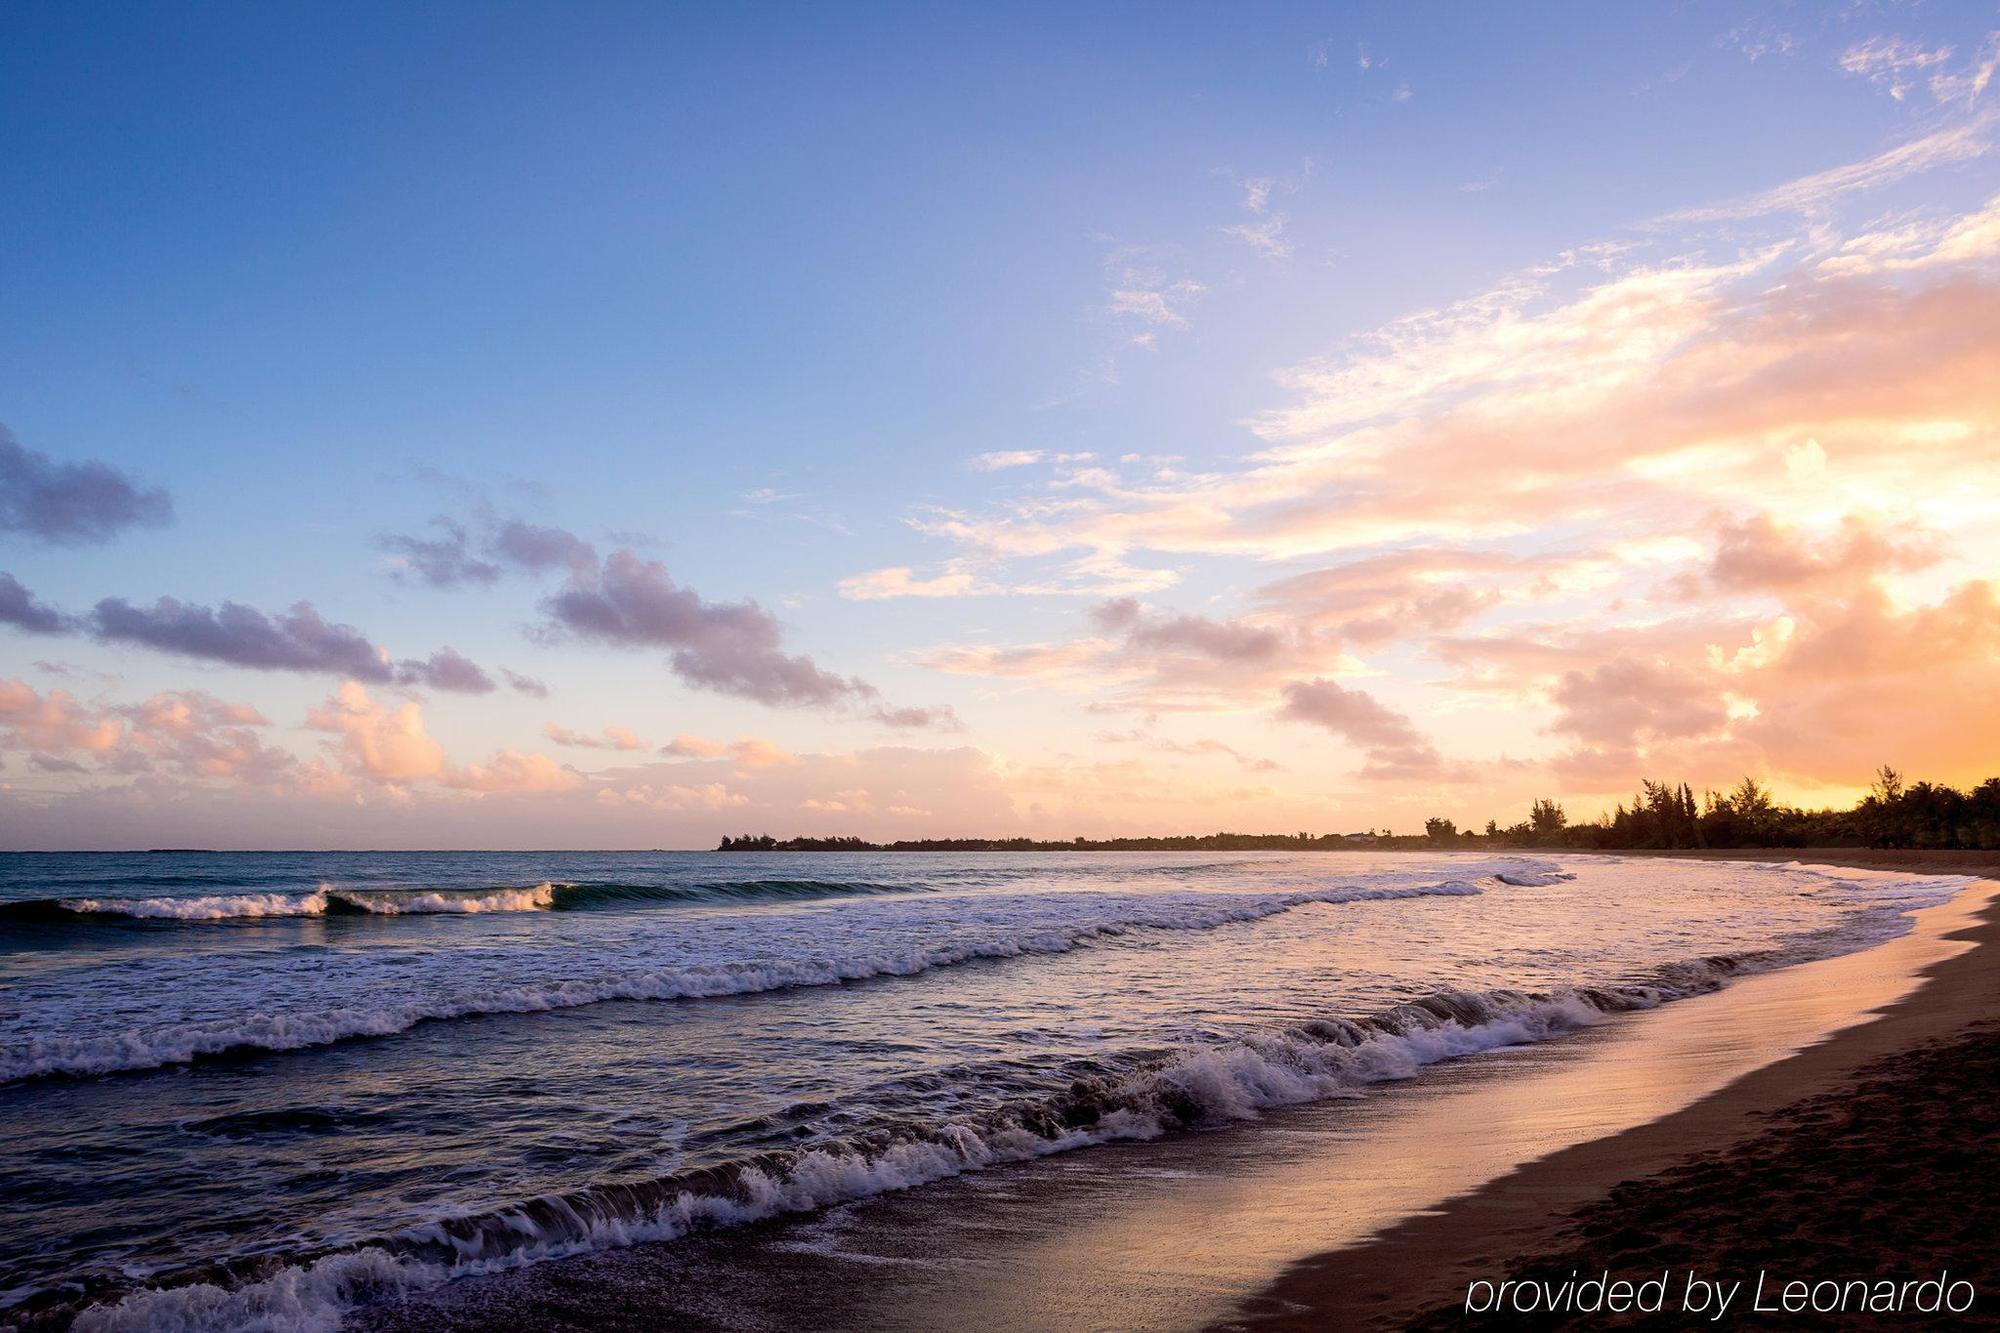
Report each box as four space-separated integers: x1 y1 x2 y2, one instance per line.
1216 849 2000 1329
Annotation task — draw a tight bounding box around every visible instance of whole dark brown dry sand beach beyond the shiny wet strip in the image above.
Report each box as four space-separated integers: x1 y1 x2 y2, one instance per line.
1224 849 2000 1329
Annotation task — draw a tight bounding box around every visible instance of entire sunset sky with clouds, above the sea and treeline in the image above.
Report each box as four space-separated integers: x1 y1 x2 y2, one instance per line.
0 2 2000 849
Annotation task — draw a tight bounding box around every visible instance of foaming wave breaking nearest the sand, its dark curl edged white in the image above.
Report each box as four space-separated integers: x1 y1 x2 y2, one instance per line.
58 957 1746 1331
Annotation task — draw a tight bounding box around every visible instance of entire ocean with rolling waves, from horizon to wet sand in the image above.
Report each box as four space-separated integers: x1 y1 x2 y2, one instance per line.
0 853 1966 1329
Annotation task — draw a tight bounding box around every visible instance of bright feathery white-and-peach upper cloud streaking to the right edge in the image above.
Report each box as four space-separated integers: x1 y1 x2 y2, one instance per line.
900 148 2000 598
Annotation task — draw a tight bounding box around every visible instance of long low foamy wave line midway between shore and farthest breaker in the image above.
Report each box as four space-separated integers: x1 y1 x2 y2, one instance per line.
0 881 1482 1083
